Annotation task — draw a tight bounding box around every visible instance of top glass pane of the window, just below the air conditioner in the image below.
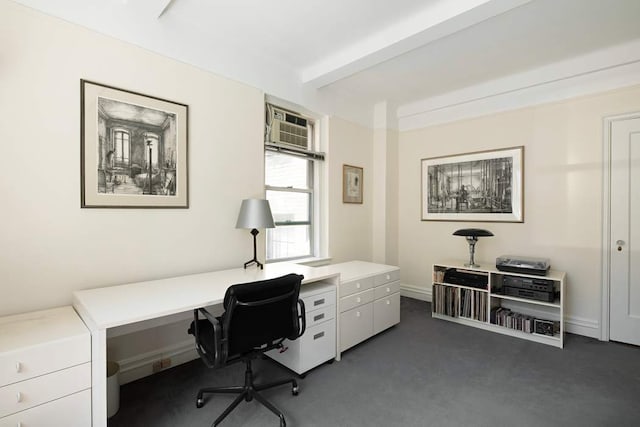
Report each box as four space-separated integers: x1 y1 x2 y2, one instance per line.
264 151 312 189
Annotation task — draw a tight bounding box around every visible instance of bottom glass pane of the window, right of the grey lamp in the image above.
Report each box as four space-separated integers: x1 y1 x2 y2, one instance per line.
267 225 311 259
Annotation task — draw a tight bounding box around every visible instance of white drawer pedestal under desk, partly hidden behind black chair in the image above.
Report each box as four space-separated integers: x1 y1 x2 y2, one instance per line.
266 283 336 374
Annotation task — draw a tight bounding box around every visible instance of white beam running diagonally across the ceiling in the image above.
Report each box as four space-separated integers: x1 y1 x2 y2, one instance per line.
301 0 531 89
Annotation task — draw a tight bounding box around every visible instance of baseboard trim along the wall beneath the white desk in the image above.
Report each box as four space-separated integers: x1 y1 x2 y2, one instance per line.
116 339 199 385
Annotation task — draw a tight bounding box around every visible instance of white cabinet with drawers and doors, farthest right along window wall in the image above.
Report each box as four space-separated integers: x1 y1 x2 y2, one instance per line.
328 261 400 352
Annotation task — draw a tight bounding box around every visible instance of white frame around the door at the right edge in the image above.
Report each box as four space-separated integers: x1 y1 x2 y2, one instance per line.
600 111 640 341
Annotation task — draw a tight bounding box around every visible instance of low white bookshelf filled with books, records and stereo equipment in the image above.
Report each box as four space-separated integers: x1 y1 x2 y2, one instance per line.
431 261 566 348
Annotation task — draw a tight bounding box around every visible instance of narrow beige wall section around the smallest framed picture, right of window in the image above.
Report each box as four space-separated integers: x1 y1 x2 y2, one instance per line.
327 117 373 262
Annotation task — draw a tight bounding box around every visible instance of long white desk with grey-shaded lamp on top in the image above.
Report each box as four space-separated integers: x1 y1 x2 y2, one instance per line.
73 263 340 427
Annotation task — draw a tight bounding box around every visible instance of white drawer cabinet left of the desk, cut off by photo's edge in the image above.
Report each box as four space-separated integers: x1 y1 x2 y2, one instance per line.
0 307 91 427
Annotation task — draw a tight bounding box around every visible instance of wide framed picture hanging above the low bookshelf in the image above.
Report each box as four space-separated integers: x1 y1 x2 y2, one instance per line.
421 146 524 222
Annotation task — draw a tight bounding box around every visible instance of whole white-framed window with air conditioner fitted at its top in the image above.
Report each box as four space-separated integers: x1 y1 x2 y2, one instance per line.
265 105 324 261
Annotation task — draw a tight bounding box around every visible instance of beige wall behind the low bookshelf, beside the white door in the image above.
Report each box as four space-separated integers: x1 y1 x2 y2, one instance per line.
398 86 640 336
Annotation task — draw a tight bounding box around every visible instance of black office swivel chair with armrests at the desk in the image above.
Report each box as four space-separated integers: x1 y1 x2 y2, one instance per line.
188 274 306 427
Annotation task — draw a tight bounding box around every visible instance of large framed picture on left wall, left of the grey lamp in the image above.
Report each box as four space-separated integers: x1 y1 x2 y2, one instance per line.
80 80 189 208
